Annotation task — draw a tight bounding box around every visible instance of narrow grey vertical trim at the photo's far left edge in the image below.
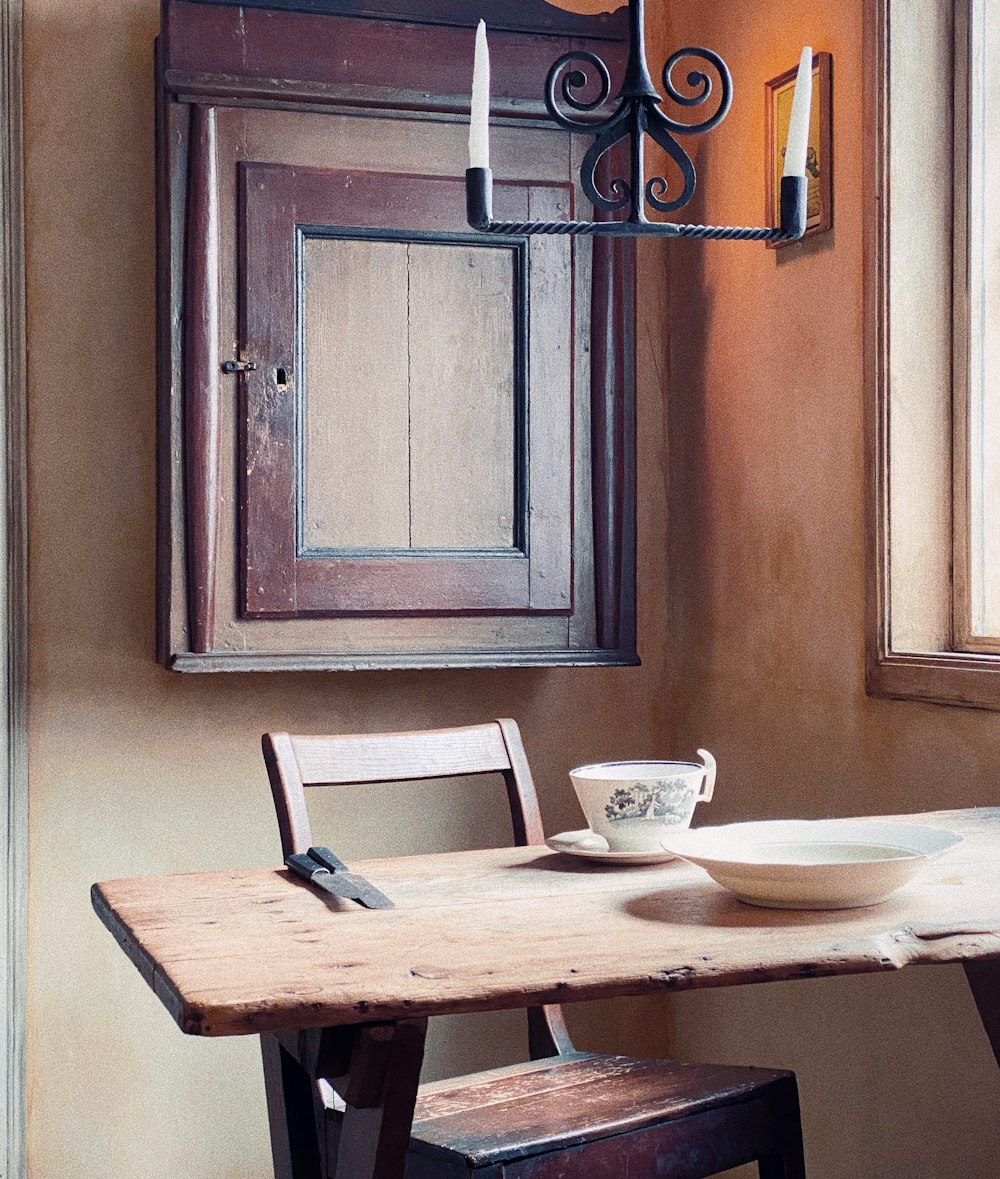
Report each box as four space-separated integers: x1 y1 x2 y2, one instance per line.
0 0 28 1179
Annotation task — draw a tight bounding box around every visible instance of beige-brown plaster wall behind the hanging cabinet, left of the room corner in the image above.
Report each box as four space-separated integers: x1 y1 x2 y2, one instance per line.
25 0 670 1179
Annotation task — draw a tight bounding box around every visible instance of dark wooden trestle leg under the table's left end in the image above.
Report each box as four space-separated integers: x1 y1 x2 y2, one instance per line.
261 1020 427 1179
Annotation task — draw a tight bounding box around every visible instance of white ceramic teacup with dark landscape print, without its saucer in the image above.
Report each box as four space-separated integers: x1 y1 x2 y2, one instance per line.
570 749 716 851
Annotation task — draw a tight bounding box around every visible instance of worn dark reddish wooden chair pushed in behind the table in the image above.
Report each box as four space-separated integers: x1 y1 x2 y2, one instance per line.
263 720 805 1179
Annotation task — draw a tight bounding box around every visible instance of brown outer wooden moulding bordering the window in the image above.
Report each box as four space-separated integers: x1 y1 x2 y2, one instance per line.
863 0 1000 710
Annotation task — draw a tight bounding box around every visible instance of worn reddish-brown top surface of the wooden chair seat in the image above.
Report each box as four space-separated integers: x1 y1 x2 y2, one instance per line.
410 1053 795 1170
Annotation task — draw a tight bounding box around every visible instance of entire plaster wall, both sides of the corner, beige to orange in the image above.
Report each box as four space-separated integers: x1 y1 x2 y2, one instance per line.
25 0 1000 1179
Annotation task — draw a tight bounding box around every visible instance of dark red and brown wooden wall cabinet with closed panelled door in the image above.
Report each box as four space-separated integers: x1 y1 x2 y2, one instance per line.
158 0 638 671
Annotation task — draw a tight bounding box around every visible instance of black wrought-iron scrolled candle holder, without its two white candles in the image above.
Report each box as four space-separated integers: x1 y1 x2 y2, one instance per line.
466 0 808 242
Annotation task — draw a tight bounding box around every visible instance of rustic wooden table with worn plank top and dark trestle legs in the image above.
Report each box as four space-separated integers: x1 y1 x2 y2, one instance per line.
93 809 1000 1179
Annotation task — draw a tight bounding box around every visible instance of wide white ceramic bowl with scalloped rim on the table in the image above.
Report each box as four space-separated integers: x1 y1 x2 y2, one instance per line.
663 818 962 909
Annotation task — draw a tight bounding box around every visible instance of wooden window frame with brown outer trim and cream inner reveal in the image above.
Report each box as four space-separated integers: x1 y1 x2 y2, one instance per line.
864 0 1000 709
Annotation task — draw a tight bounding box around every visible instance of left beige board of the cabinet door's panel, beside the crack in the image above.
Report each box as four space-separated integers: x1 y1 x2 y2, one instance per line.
298 237 410 548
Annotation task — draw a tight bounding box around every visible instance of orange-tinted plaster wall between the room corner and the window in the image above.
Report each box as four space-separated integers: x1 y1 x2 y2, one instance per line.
669 0 1000 1179
